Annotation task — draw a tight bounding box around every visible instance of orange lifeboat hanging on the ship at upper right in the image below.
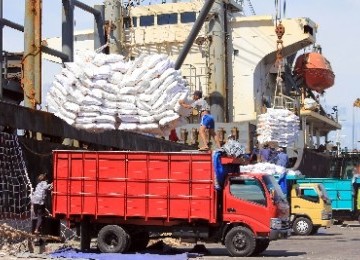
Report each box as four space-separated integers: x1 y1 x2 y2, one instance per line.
294 52 335 93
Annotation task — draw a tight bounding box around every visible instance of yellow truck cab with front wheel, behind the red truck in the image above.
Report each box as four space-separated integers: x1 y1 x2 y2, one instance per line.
288 180 332 236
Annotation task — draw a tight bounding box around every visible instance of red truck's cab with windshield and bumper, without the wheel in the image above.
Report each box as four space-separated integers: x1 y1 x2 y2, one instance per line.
222 173 289 237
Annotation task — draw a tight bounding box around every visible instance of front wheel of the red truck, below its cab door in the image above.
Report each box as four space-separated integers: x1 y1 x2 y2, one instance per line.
225 227 256 256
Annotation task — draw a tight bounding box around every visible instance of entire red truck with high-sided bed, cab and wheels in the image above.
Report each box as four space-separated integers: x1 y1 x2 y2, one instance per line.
52 151 290 256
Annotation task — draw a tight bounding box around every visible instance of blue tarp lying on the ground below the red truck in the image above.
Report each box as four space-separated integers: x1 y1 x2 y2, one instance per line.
50 248 188 260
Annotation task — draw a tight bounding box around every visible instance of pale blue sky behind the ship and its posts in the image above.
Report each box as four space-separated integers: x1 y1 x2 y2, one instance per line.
2 0 360 149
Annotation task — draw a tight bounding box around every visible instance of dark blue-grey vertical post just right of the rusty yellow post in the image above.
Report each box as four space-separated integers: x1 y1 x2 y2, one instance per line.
62 0 74 62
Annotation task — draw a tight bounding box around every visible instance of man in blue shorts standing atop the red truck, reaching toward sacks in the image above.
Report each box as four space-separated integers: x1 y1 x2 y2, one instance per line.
179 90 221 151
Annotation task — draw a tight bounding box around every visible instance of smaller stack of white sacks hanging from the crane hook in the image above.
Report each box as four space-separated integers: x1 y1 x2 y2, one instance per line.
256 108 300 147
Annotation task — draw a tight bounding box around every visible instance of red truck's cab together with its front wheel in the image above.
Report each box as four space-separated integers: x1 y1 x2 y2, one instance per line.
220 169 291 256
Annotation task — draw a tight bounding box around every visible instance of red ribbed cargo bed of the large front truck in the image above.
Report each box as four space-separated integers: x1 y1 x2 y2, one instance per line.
53 151 217 223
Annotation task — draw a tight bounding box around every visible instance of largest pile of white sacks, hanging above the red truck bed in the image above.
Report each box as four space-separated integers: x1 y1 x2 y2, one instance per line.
47 52 191 135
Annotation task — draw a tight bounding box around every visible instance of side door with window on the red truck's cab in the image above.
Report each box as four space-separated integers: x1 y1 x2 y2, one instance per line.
223 177 270 230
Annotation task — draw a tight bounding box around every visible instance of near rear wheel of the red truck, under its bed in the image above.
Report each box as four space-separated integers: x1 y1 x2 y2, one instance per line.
97 225 130 253
